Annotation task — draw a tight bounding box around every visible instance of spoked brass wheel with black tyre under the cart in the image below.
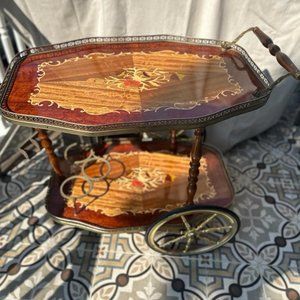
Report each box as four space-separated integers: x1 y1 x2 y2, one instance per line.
146 205 240 255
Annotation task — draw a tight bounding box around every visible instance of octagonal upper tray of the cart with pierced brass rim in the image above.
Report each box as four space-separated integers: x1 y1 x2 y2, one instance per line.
0 35 270 135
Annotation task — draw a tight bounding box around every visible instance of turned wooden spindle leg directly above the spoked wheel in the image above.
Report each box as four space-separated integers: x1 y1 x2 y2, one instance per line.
187 128 202 204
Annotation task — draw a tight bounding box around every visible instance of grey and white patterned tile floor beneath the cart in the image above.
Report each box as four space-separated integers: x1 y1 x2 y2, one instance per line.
0 92 300 300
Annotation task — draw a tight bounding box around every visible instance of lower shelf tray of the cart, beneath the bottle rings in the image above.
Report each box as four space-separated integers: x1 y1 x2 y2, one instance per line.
46 142 234 232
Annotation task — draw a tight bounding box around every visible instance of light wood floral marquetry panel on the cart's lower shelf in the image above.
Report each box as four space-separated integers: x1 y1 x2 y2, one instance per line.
66 151 216 217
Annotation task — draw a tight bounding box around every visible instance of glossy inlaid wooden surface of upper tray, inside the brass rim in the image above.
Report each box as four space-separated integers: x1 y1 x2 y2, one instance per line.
2 42 265 131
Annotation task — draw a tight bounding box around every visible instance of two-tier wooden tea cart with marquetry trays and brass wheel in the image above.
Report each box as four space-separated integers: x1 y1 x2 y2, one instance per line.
1 27 300 255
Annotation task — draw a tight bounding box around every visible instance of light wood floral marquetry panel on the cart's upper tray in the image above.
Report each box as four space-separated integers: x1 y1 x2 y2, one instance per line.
29 50 242 115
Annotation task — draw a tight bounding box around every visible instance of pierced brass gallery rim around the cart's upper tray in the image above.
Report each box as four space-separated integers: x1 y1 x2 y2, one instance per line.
0 35 270 136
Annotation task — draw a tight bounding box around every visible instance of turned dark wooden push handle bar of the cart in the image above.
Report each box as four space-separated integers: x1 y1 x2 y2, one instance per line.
252 27 300 80
